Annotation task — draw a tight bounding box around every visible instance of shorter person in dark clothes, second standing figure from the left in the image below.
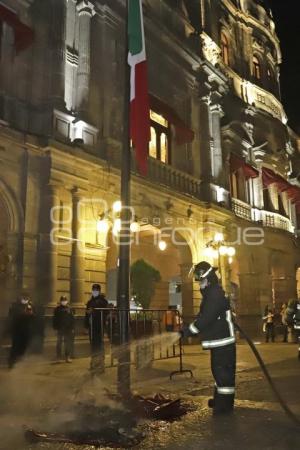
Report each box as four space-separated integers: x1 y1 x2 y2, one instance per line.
53 295 75 362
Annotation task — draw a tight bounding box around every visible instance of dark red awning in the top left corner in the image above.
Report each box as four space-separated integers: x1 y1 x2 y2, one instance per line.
0 5 34 53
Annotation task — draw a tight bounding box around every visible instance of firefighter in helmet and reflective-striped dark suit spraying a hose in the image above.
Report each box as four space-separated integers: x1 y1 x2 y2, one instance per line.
181 261 236 415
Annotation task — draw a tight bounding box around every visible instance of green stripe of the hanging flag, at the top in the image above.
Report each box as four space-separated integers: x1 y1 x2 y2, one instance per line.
128 0 143 55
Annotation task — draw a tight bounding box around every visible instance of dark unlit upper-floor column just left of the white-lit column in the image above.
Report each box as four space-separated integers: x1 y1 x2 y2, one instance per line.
49 0 66 110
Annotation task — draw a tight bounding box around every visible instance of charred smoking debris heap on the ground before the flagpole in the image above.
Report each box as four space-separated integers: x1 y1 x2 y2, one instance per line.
25 394 190 448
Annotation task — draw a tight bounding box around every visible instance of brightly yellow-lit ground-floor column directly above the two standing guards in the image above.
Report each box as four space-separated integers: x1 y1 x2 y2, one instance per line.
70 190 85 305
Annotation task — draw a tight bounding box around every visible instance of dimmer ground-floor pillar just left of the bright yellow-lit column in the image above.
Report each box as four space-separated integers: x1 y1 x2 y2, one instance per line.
39 184 59 305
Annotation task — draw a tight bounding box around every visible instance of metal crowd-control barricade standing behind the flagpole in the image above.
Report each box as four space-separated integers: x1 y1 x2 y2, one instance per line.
45 306 193 378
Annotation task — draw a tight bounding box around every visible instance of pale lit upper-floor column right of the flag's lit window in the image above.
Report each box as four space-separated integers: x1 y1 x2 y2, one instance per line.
209 102 224 184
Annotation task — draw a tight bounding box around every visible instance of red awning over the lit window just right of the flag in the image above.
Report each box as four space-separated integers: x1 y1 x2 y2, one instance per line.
149 94 195 144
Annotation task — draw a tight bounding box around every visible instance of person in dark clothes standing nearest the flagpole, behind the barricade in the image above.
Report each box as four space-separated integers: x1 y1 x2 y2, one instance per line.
85 283 109 372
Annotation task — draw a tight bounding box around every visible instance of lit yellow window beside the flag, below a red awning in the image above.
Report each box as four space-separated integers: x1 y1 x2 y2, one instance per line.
149 110 170 164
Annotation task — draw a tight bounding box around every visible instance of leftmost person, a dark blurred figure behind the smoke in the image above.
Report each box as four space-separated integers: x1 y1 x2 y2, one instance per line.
8 293 34 368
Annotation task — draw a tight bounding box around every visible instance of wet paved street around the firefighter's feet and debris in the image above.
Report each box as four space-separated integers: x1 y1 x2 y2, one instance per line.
0 343 300 450
